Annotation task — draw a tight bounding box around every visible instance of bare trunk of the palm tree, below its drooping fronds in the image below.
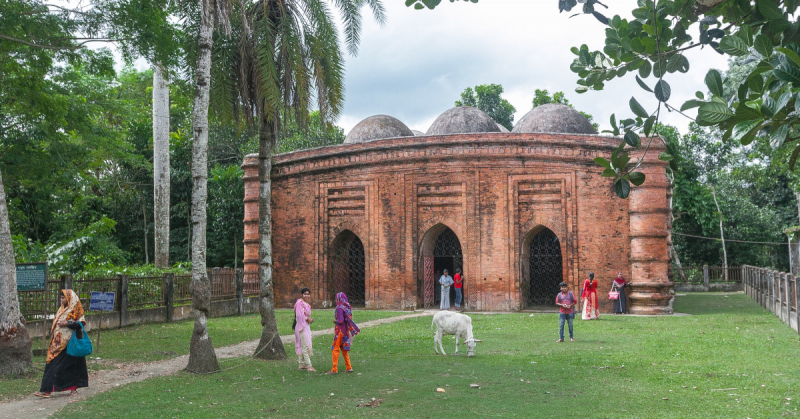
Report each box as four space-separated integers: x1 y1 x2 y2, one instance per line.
253 115 286 359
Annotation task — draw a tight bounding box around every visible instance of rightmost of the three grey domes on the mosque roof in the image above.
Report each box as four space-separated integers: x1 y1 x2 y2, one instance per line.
511 103 597 134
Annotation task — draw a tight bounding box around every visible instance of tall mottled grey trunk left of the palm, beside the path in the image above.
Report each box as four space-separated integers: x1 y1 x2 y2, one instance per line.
186 0 219 373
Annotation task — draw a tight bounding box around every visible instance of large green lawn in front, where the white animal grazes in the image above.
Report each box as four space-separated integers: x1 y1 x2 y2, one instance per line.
57 293 800 418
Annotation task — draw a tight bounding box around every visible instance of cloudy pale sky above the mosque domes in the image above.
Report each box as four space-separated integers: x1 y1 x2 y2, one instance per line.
338 0 727 133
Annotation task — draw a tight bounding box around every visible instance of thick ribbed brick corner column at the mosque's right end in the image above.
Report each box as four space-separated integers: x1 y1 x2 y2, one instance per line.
628 142 675 314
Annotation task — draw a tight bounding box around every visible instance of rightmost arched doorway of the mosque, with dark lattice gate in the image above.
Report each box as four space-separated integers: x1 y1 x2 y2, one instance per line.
520 227 564 308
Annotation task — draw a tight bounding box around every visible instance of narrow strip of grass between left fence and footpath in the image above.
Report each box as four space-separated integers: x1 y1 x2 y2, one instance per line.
0 310 408 402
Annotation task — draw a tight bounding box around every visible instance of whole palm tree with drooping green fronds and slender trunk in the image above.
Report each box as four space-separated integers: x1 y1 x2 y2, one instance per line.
212 0 385 359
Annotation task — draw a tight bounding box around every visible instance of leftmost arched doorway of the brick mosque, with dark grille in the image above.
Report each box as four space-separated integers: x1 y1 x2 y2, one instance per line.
329 230 366 307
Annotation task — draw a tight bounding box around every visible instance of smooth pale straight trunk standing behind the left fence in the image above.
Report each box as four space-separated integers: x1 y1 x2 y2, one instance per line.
153 63 170 269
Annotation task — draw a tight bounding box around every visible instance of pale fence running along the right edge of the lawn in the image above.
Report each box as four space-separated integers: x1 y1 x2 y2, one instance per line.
742 265 800 332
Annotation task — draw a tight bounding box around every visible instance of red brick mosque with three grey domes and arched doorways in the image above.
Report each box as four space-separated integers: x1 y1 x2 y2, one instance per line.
242 104 674 314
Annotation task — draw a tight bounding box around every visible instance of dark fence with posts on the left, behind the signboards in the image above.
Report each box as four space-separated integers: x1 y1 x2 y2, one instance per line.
17 268 261 324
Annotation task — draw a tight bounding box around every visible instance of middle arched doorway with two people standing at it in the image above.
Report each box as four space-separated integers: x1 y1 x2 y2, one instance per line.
418 224 467 308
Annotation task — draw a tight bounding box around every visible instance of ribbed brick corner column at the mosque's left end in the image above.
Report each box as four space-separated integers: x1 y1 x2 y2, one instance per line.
242 154 258 273
